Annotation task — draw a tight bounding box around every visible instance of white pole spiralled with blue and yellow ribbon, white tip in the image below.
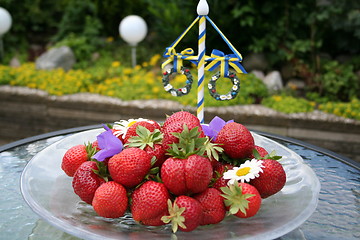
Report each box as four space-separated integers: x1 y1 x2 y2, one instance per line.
197 0 209 123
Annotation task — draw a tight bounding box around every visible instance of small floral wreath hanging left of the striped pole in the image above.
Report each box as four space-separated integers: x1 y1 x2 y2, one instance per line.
162 66 193 97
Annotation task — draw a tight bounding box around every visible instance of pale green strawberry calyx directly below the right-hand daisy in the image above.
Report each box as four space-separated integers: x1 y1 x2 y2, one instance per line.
220 184 255 215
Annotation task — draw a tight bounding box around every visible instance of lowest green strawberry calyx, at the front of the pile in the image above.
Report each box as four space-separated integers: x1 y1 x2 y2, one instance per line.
161 199 186 233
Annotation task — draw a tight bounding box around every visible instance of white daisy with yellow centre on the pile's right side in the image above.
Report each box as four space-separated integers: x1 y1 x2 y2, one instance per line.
223 158 264 185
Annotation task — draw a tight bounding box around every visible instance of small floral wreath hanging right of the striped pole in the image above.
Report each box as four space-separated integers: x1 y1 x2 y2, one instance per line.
208 71 240 101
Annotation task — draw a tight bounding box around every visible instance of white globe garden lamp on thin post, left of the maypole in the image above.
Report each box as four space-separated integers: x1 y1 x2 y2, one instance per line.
119 15 147 67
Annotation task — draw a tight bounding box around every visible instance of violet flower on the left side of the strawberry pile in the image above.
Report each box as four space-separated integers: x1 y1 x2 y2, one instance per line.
93 125 123 162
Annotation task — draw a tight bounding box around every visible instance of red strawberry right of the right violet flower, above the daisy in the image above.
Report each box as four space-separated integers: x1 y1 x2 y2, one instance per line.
215 122 255 159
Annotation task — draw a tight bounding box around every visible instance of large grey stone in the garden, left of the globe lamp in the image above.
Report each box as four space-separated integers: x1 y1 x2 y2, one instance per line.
36 46 76 71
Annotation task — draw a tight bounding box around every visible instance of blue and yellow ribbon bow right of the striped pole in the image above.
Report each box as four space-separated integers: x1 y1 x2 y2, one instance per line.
205 49 247 77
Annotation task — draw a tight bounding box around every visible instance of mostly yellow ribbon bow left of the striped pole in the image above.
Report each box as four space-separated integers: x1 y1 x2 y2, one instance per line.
161 47 197 72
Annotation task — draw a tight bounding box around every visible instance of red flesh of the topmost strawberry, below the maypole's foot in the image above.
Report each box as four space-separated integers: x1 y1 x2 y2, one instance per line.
162 111 205 149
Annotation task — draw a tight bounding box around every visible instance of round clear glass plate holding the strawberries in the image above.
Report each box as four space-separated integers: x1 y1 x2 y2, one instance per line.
21 129 320 240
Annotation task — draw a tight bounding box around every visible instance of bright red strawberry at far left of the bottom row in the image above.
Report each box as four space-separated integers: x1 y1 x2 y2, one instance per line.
92 181 128 218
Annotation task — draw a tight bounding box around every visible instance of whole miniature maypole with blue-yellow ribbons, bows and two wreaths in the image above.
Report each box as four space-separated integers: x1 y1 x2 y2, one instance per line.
162 0 247 123
